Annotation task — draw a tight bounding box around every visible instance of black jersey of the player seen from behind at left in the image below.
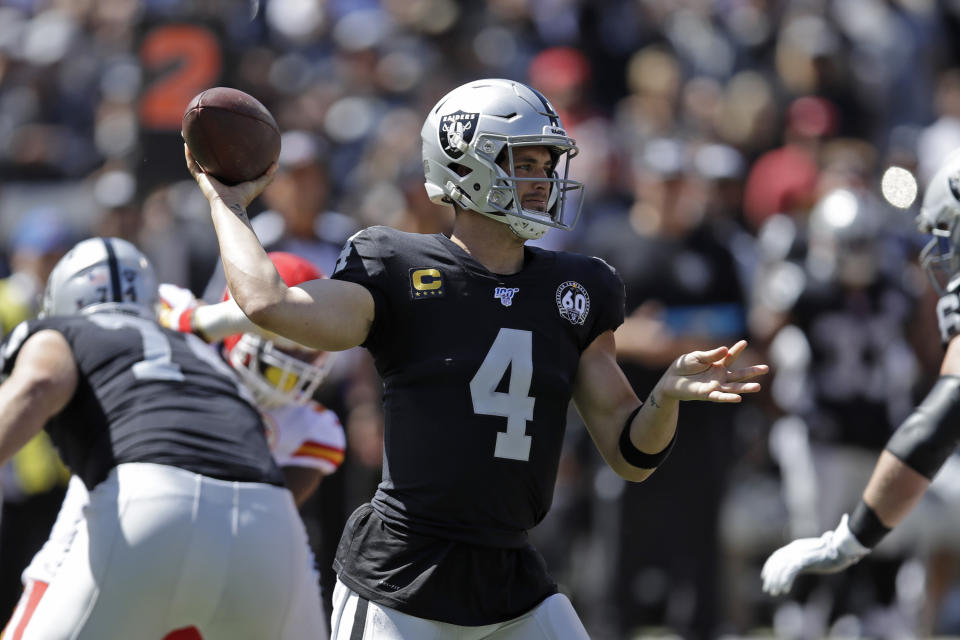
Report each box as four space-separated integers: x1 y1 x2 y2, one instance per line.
0 313 283 489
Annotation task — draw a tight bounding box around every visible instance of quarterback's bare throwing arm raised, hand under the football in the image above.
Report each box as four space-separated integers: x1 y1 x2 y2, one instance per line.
184 145 374 351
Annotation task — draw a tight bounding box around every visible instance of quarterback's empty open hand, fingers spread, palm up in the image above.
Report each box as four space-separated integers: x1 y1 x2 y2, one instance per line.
660 340 769 402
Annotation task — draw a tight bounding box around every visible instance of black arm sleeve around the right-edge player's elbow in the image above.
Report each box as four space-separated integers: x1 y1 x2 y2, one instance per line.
887 376 960 479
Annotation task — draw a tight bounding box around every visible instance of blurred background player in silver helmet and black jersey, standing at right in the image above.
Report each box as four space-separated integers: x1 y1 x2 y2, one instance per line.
764 185 919 635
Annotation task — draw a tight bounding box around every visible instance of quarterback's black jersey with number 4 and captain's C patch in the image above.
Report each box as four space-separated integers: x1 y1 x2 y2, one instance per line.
332 227 624 547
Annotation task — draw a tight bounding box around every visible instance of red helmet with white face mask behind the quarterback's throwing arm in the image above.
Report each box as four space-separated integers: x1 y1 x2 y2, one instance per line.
223 251 333 408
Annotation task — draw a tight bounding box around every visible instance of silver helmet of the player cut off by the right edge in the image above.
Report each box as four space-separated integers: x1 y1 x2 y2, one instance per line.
917 152 960 296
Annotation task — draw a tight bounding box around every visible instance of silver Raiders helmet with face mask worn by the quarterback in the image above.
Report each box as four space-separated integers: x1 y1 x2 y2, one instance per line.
420 78 583 239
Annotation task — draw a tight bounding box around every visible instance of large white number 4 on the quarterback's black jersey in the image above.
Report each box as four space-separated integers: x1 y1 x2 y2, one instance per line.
470 329 535 461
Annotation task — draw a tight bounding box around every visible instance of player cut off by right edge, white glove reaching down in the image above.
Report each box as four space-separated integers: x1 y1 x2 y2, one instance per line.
761 154 960 595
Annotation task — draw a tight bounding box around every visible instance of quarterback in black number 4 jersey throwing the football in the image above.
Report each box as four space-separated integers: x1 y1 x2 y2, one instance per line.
187 79 766 639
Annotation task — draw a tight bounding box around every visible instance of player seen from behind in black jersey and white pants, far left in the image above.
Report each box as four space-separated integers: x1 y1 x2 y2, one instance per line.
0 238 324 640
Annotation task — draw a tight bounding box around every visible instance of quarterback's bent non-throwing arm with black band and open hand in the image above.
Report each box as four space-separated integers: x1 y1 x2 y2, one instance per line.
573 331 767 482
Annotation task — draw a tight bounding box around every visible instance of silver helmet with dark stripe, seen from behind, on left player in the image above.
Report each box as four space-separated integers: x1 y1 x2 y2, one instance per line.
40 238 158 319
